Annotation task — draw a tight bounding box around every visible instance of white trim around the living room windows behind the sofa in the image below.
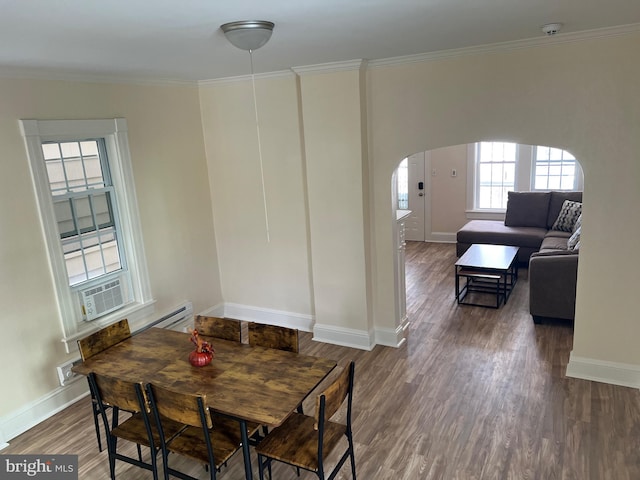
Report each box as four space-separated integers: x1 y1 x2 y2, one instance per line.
466 142 584 220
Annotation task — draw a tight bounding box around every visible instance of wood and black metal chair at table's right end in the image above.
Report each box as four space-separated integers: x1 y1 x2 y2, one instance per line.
256 361 356 480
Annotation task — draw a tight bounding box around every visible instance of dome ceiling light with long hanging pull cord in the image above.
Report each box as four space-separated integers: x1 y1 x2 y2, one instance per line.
220 20 274 243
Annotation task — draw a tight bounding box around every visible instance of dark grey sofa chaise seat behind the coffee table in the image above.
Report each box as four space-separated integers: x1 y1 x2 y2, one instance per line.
456 220 548 249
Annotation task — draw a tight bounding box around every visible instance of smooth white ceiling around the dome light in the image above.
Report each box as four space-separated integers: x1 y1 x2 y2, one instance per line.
0 0 640 81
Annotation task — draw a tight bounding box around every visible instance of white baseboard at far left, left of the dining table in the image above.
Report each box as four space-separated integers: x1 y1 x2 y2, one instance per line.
0 377 89 449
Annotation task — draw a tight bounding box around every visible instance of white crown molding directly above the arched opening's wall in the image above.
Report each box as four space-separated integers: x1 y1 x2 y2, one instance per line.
369 23 640 68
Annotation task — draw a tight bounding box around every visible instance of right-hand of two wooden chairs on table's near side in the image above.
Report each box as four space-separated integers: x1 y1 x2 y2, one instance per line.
146 384 258 480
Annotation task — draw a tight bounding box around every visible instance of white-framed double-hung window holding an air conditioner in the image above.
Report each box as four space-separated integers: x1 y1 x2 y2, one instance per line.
20 118 153 348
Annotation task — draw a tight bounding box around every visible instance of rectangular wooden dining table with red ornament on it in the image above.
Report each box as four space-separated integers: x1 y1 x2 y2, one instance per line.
72 327 336 480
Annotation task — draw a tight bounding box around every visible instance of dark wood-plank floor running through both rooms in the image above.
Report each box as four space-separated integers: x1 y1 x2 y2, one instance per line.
5 242 640 480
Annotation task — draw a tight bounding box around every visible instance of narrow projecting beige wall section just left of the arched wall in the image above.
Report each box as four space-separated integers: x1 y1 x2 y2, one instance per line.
300 69 371 342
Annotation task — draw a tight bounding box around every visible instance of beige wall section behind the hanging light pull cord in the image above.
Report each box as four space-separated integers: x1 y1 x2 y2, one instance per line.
200 74 313 316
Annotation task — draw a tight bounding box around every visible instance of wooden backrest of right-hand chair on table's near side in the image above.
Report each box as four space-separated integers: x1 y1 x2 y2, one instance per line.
147 384 213 429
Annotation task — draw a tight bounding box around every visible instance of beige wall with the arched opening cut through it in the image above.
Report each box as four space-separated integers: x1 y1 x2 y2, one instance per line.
369 34 640 366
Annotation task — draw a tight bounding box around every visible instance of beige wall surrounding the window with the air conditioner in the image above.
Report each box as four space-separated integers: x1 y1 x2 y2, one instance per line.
0 79 222 418
